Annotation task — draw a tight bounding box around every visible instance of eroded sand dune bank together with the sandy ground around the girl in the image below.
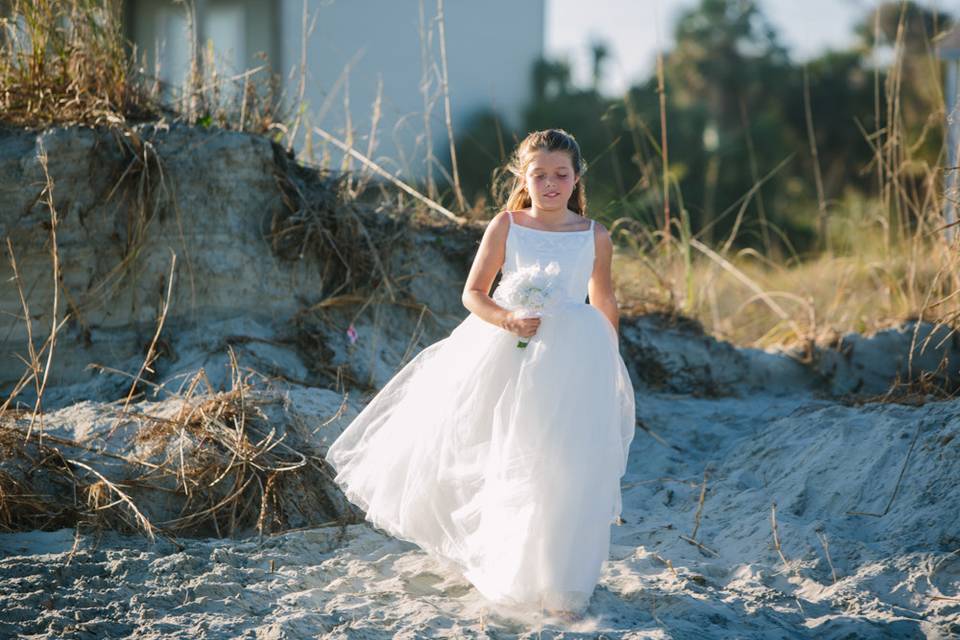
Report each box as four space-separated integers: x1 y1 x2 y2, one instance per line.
0 127 960 638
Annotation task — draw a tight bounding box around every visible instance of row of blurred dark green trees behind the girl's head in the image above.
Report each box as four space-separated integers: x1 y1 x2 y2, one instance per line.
457 0 949 255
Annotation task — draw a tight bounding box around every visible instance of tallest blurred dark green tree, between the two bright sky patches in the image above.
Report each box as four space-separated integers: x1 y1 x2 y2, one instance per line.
665 0 797 244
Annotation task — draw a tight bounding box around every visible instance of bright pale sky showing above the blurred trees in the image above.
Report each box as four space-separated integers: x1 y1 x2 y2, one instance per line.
545 0 956 95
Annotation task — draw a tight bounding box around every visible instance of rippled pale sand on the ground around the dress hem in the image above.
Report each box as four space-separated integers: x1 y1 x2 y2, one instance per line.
0 382 960 638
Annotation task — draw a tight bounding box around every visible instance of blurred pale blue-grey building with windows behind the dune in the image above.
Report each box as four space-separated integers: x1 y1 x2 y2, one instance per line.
124 0 545 180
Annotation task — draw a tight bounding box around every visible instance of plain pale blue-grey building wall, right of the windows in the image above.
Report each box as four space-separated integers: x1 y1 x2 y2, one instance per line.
280 0 545 179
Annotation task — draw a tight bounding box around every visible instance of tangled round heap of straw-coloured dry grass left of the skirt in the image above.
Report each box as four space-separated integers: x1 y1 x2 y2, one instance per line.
122 351 340 536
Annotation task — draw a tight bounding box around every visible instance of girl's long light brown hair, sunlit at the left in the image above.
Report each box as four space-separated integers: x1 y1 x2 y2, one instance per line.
493 129 587 216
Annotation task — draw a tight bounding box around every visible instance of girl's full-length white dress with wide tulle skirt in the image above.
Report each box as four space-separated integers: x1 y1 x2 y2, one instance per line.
326 213 636 612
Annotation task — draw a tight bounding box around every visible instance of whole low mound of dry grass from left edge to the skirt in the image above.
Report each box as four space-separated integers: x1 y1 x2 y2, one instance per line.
0 352 356 539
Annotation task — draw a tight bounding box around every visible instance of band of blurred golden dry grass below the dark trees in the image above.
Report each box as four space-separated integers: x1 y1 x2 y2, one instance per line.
614 222 960 348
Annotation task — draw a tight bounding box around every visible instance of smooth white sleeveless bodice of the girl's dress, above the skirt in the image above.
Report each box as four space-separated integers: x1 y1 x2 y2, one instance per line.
503 211 596 302
